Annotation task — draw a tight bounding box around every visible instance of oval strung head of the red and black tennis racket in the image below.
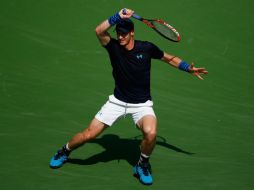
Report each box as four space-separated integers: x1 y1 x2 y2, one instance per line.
149 19 181 42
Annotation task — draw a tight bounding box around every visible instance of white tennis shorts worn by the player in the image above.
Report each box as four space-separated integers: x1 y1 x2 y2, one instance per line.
95 95 156 126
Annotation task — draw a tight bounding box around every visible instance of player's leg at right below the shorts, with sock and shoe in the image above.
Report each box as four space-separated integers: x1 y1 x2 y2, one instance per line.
134 115 157 185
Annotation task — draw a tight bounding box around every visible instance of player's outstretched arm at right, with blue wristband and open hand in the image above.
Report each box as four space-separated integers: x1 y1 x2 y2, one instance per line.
161 52 208 80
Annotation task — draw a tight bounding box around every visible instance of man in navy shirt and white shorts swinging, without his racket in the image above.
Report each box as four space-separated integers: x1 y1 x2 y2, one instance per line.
50 9 207 185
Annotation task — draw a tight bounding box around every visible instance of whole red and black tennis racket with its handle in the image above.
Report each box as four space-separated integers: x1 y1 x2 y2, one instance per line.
123 9 181 42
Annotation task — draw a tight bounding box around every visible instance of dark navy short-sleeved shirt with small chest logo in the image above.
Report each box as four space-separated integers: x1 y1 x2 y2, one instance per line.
104 38 164 103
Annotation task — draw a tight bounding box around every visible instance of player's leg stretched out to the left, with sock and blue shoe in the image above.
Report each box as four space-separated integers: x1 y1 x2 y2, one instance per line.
50 118 107 168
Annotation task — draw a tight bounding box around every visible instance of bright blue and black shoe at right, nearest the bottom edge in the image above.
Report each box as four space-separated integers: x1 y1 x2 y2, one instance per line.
133 163 153 185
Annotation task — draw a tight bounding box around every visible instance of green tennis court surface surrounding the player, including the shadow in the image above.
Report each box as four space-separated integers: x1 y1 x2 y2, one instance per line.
0 0 254 190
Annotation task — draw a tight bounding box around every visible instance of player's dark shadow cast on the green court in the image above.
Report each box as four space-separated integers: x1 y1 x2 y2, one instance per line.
68 134 195 166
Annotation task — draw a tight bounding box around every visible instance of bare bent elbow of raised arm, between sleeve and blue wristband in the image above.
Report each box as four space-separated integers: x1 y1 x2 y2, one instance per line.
95 20 111 46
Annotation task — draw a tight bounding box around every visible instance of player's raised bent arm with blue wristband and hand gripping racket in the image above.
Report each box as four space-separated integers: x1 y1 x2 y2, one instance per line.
95 9 134 46
